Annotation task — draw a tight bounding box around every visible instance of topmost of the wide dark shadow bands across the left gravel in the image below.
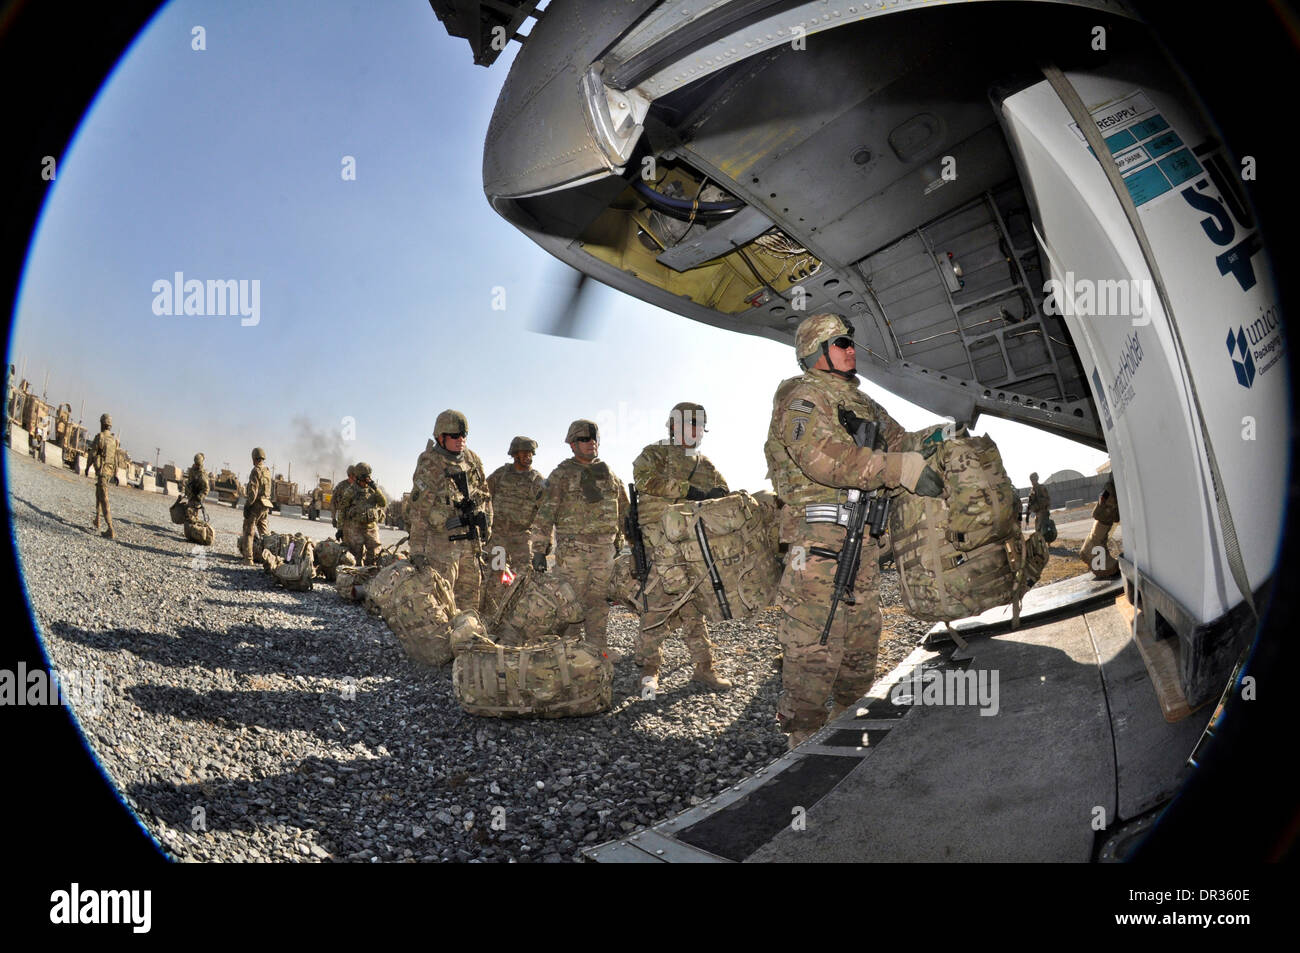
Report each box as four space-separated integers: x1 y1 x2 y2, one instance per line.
44 616 406 679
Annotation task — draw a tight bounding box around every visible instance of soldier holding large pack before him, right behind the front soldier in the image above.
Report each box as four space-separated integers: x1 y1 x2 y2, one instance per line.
632 402 732 692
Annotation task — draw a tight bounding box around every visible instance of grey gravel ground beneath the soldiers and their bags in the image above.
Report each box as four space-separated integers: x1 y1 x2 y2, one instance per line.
5 449 1066 862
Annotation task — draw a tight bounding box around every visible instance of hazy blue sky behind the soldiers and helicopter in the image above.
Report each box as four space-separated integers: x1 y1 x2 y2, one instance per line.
10 0 1105 493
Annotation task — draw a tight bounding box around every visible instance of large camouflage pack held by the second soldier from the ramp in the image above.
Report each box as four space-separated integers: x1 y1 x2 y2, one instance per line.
647 490 781 621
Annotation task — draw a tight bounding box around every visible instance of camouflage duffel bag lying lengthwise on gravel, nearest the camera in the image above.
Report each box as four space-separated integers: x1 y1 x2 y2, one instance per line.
451 612 614 718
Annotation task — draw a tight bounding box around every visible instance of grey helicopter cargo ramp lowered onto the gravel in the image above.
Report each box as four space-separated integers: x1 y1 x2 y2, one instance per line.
584 576 1212 863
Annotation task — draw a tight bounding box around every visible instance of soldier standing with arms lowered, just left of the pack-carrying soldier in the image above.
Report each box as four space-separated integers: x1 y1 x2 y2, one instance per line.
528 420 628 660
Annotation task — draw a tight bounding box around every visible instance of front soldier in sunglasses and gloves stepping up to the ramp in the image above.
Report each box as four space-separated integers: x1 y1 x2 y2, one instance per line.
763 313 944 748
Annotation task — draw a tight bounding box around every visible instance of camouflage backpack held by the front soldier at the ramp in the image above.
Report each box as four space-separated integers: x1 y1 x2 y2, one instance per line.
889 428 1048 625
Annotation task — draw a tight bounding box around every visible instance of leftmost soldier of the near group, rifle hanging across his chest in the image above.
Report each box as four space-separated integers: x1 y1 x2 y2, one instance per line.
407 410 493 611
